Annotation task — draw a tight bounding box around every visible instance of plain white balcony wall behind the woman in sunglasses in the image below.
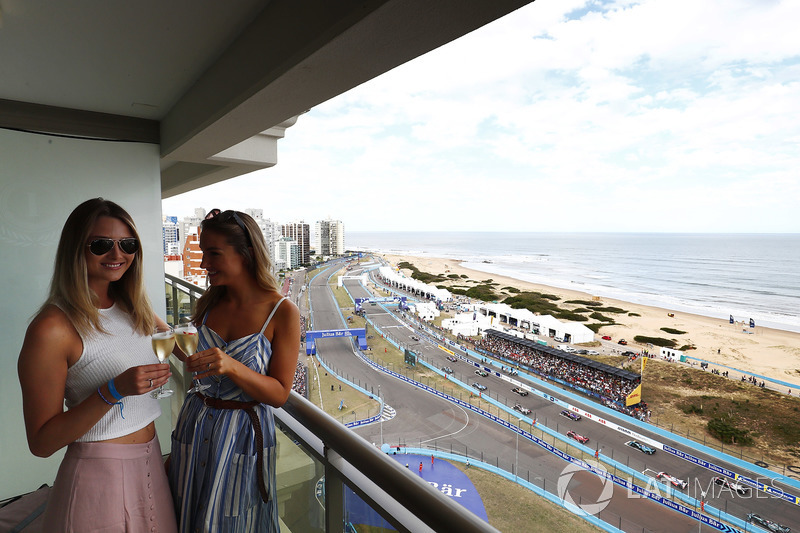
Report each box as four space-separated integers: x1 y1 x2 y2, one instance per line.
0 129 172 500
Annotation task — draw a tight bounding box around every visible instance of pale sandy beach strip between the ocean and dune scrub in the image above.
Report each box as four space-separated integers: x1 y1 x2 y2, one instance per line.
383 251 800 384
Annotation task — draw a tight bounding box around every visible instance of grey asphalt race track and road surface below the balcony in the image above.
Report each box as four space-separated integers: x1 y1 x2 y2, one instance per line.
296 260 800 531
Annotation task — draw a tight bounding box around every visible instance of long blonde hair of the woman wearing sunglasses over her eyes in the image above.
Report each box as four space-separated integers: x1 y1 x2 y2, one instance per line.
40 198 154 336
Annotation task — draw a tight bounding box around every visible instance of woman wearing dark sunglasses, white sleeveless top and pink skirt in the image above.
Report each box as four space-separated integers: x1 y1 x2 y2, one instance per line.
18 198 177 532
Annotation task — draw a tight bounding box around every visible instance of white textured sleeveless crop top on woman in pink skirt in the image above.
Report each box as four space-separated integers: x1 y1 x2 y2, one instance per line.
64 304 161 442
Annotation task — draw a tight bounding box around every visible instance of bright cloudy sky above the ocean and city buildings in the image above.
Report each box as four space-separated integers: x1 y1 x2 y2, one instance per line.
163 0 800 233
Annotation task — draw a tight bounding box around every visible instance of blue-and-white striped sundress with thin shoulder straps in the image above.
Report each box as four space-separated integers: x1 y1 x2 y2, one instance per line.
169 298 286 533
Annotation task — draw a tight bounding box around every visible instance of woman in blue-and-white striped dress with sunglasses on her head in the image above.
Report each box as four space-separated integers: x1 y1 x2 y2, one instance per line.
169 211 300 533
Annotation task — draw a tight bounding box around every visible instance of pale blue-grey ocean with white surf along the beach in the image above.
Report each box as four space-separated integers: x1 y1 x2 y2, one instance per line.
346 232 800 332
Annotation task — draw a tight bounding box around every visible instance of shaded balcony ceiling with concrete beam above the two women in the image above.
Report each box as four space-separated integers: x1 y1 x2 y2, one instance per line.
0 0 531 197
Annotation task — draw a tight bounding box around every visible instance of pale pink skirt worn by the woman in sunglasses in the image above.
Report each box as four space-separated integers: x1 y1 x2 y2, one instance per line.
42 436 178 533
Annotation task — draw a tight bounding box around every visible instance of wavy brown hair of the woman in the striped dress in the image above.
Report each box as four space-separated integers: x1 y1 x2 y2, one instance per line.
192 209 279 324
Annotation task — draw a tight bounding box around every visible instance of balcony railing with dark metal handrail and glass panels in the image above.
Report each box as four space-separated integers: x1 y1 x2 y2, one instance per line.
166 275 497 533
